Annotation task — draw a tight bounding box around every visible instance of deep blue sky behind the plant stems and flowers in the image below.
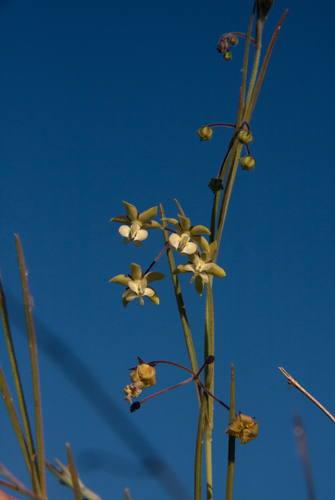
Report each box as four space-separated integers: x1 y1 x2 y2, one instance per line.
0 0 335 500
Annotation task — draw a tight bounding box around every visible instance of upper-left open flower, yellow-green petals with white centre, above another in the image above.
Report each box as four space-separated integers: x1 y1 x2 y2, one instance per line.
111 201 162 247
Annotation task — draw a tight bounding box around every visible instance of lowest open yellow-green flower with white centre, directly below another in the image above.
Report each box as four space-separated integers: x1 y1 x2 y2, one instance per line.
109 263 165 307
